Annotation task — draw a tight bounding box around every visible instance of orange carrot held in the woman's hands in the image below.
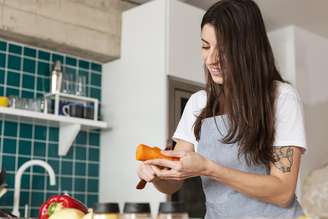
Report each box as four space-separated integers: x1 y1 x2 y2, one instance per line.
136 144 179 161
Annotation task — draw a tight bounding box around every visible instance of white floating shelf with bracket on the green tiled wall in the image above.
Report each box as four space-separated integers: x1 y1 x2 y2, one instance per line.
0 107 108 156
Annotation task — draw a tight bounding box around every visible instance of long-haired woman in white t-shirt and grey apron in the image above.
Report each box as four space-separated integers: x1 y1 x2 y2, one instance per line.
138 0 306 219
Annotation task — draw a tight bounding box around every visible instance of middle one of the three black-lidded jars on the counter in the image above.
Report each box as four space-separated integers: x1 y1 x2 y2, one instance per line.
123 202 151 219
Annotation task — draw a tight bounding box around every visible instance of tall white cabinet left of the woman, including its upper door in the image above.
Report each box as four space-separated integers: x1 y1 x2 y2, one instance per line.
100 0 203 216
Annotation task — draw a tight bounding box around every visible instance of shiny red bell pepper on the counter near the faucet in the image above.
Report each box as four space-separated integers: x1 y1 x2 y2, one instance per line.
39 194 88 219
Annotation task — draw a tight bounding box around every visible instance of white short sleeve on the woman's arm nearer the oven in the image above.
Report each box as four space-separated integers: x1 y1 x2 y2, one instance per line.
172 91 206 147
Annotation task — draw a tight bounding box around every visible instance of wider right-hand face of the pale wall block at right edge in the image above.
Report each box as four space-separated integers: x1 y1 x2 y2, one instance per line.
295 27 328 180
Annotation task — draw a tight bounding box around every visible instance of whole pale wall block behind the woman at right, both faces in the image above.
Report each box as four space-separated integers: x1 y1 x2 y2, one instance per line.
269 26 328 196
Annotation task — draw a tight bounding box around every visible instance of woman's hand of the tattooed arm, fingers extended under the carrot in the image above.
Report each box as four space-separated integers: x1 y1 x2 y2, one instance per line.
145 151 208 180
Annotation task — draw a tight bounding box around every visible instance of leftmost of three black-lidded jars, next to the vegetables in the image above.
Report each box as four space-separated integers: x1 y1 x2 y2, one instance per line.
93 202 120 219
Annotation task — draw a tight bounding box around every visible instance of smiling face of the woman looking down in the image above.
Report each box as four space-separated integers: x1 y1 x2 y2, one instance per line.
202 24 223 84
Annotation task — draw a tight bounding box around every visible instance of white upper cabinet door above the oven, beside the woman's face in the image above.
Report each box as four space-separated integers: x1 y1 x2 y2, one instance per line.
167 1 205 83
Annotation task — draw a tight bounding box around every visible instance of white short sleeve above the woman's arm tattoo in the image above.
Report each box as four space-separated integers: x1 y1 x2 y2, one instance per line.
273 85 307 149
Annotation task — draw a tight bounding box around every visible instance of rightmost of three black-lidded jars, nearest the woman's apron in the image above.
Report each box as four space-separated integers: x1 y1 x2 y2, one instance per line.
157 202 189 219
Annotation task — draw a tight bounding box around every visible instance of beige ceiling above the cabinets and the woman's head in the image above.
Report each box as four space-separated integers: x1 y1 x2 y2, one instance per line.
125 0 328 38
